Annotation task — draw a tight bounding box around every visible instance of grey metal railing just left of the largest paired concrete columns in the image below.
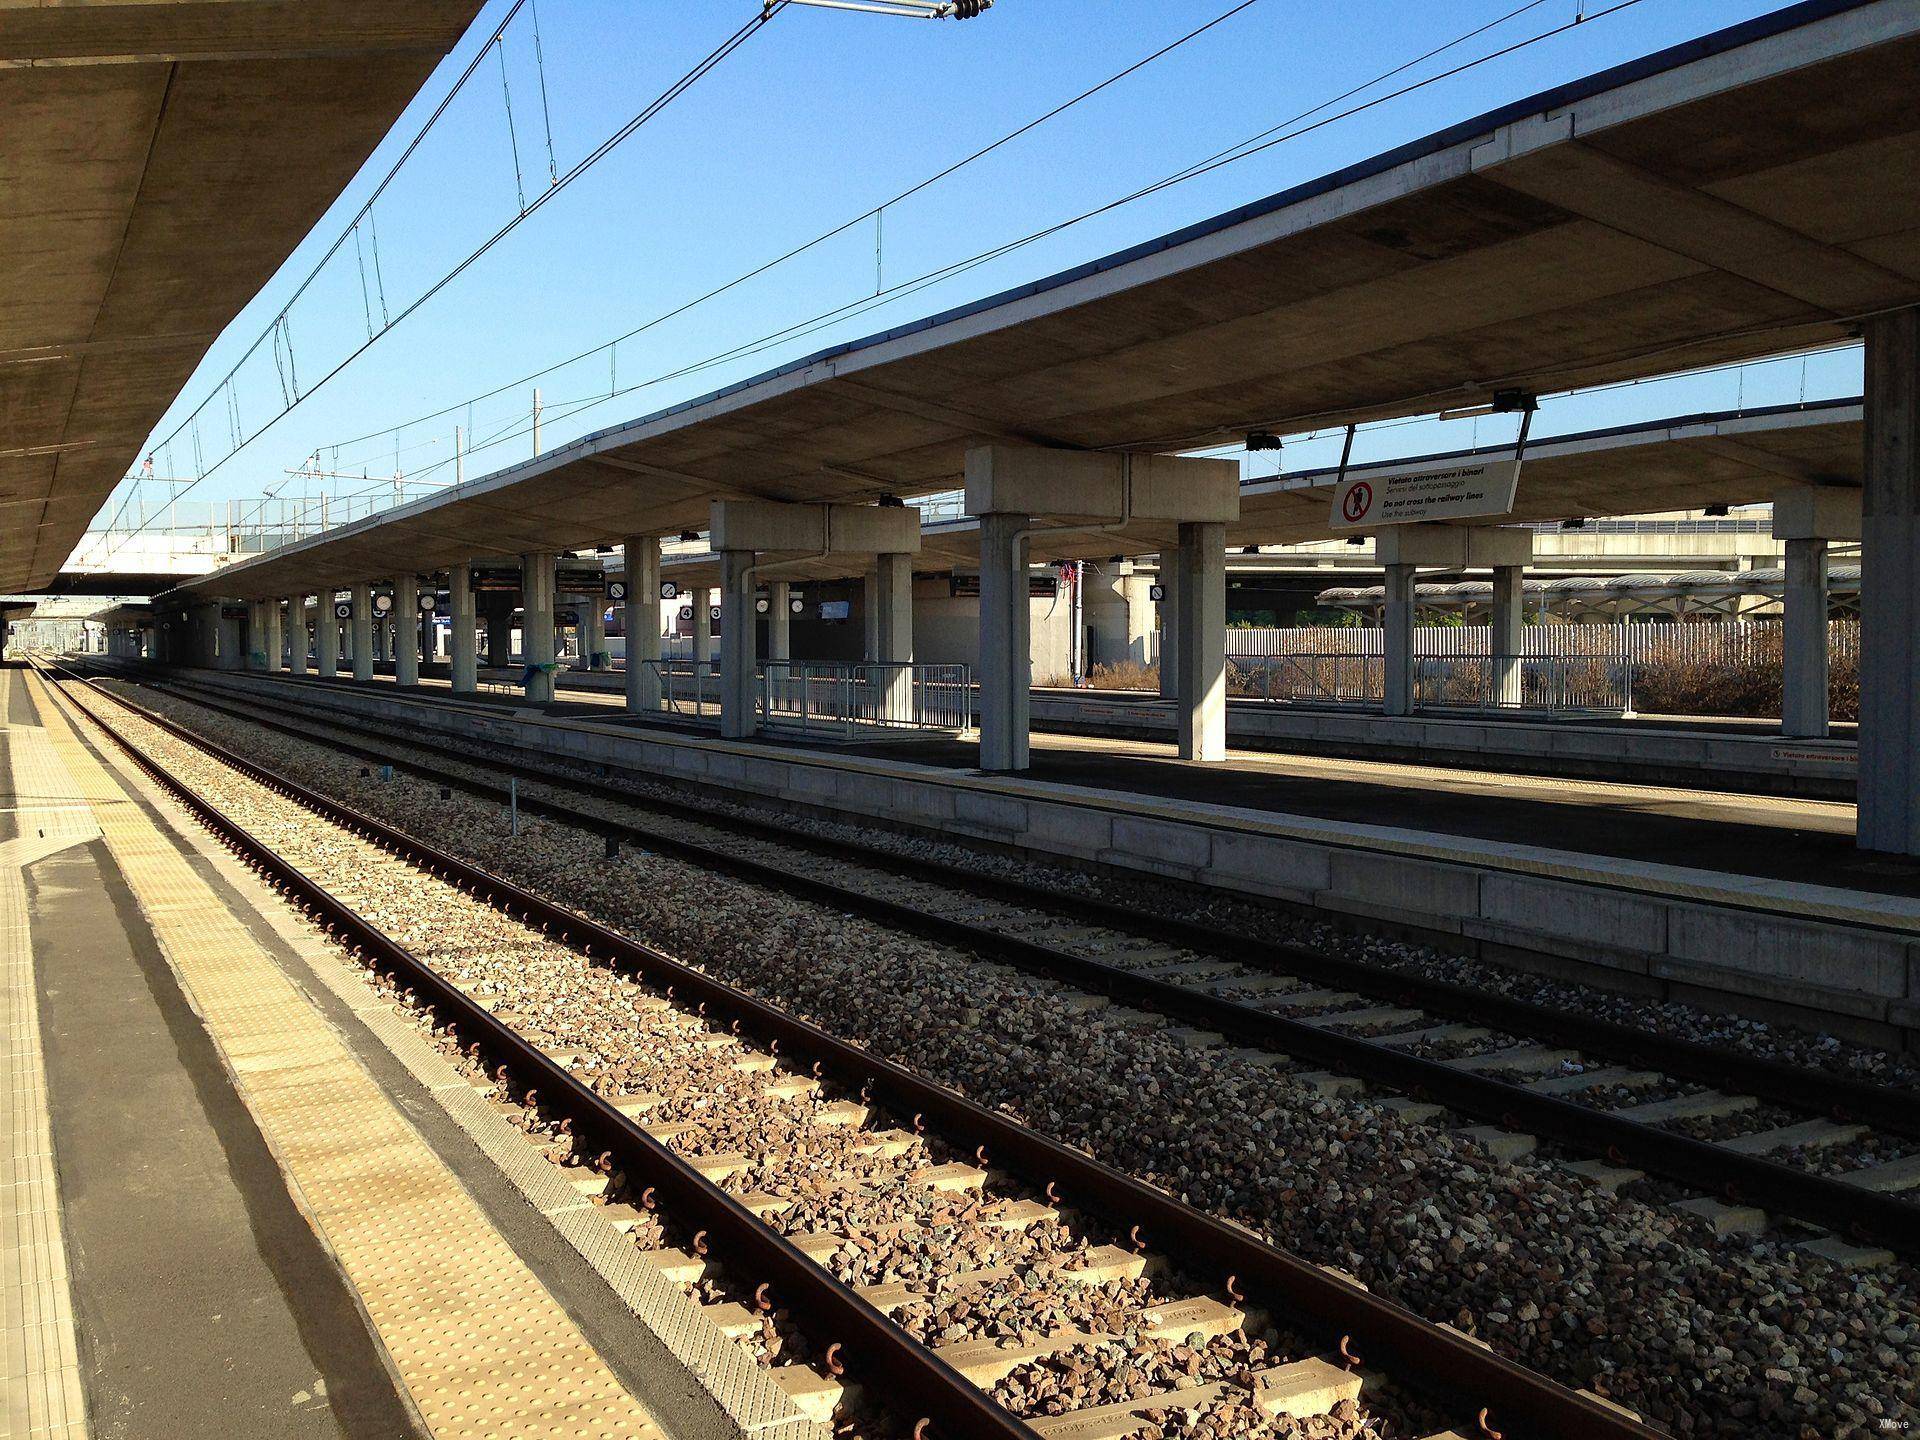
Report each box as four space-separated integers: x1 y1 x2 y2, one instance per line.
760 660 973 735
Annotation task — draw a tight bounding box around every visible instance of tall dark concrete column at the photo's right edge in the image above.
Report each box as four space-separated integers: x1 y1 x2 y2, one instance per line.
1857 309 1920 854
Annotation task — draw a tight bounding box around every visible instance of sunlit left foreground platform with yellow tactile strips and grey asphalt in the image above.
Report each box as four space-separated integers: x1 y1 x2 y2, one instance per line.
0 666 726 1440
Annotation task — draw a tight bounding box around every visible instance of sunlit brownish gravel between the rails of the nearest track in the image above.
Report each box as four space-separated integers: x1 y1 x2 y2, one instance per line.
82 687 1404 1436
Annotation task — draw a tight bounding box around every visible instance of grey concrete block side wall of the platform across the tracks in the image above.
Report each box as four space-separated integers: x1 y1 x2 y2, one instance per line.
153 674 1920 1046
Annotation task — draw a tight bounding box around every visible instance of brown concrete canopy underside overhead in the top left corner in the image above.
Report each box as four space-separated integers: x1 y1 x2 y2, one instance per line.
0 0 480 589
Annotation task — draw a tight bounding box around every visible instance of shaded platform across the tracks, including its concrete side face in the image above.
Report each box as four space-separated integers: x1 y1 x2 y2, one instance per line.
108 672 1920 1044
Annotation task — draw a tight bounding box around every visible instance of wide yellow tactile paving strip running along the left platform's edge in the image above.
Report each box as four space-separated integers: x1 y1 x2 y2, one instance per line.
24 682 675 1440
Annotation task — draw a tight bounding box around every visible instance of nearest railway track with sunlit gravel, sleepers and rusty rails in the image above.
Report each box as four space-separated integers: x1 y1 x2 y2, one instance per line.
30 668 1653 1440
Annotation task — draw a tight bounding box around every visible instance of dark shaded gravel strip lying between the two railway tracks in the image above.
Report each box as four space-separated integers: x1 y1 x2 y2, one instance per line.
105 683 1920 1436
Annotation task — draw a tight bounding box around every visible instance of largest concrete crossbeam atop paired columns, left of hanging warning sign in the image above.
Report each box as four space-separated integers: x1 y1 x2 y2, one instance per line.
966 445 1240 524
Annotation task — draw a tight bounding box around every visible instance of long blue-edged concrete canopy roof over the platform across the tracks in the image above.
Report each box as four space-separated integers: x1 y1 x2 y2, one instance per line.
186 0 1920 597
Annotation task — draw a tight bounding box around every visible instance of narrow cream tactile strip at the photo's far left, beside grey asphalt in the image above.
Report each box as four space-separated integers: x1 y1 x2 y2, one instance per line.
0 670 100 1440
